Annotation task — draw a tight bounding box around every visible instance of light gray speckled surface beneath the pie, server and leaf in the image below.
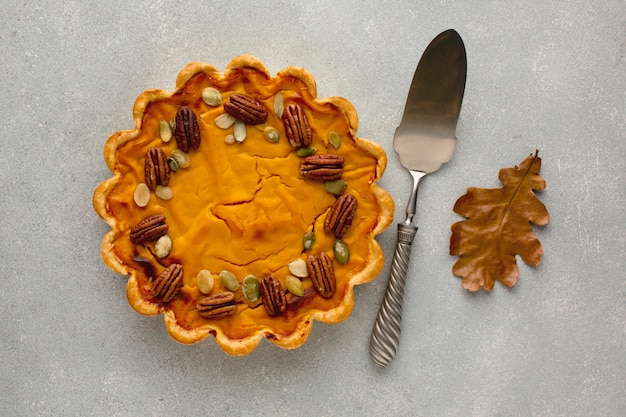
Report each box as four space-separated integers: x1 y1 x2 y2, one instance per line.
0 0 626 417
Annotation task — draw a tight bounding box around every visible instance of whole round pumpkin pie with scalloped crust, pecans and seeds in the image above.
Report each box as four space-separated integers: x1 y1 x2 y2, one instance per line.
93 55 394 355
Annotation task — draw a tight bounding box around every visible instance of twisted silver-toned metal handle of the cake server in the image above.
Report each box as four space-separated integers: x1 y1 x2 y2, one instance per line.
370 223 417 368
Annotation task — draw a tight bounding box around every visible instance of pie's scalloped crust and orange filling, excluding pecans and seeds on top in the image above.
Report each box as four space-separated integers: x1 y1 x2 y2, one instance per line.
93 55 394 355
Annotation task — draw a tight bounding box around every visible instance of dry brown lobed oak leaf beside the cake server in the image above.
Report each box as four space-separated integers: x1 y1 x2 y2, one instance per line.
450 151 550 291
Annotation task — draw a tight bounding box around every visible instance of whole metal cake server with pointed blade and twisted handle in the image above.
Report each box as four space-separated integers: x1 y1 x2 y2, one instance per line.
370 29 467 367
